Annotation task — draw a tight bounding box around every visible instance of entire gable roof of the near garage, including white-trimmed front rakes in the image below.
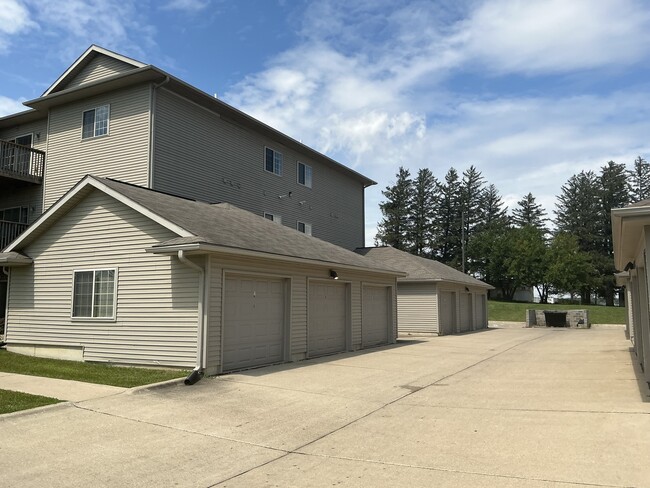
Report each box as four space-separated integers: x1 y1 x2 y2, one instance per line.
2 175 403 276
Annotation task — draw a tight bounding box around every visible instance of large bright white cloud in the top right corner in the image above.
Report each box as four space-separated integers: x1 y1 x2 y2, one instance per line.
456 0 650 74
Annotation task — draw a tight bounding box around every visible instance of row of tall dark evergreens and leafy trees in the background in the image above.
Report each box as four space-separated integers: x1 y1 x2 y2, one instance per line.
375 156 650 305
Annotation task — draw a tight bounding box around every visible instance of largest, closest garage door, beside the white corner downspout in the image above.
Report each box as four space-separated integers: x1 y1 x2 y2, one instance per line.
223 276 285 371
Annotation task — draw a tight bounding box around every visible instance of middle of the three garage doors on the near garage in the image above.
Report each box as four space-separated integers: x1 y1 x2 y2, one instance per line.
307 282 348 357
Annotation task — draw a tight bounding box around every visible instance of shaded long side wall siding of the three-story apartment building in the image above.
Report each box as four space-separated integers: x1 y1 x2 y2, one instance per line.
152 89 364 249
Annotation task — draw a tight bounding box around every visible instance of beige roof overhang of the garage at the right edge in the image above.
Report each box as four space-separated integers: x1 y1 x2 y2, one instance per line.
612 202 650 270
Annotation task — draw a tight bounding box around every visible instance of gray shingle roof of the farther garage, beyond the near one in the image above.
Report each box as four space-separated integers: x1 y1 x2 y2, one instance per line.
355 246 494 289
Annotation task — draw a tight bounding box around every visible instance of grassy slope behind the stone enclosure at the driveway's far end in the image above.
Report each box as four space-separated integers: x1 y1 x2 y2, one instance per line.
488 300 627 324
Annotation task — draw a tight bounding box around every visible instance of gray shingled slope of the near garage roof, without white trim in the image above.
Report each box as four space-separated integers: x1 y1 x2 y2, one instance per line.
95 178 393 273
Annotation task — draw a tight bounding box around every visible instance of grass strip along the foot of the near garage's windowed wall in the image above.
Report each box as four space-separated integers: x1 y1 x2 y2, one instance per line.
0 349 189 388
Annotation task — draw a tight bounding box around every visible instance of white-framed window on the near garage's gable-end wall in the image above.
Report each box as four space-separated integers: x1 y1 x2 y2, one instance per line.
72 269 115 319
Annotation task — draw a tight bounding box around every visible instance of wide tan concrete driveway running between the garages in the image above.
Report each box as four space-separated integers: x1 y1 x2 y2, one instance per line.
0 329 650 488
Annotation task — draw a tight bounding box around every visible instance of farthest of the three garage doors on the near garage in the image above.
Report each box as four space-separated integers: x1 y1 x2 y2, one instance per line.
361 286 390 347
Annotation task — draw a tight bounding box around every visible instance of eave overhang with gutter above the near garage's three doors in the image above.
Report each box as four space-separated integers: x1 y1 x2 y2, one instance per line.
145 242 406 278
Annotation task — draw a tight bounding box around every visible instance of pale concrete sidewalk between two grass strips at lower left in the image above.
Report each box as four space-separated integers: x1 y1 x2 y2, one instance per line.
0 372 127 402
